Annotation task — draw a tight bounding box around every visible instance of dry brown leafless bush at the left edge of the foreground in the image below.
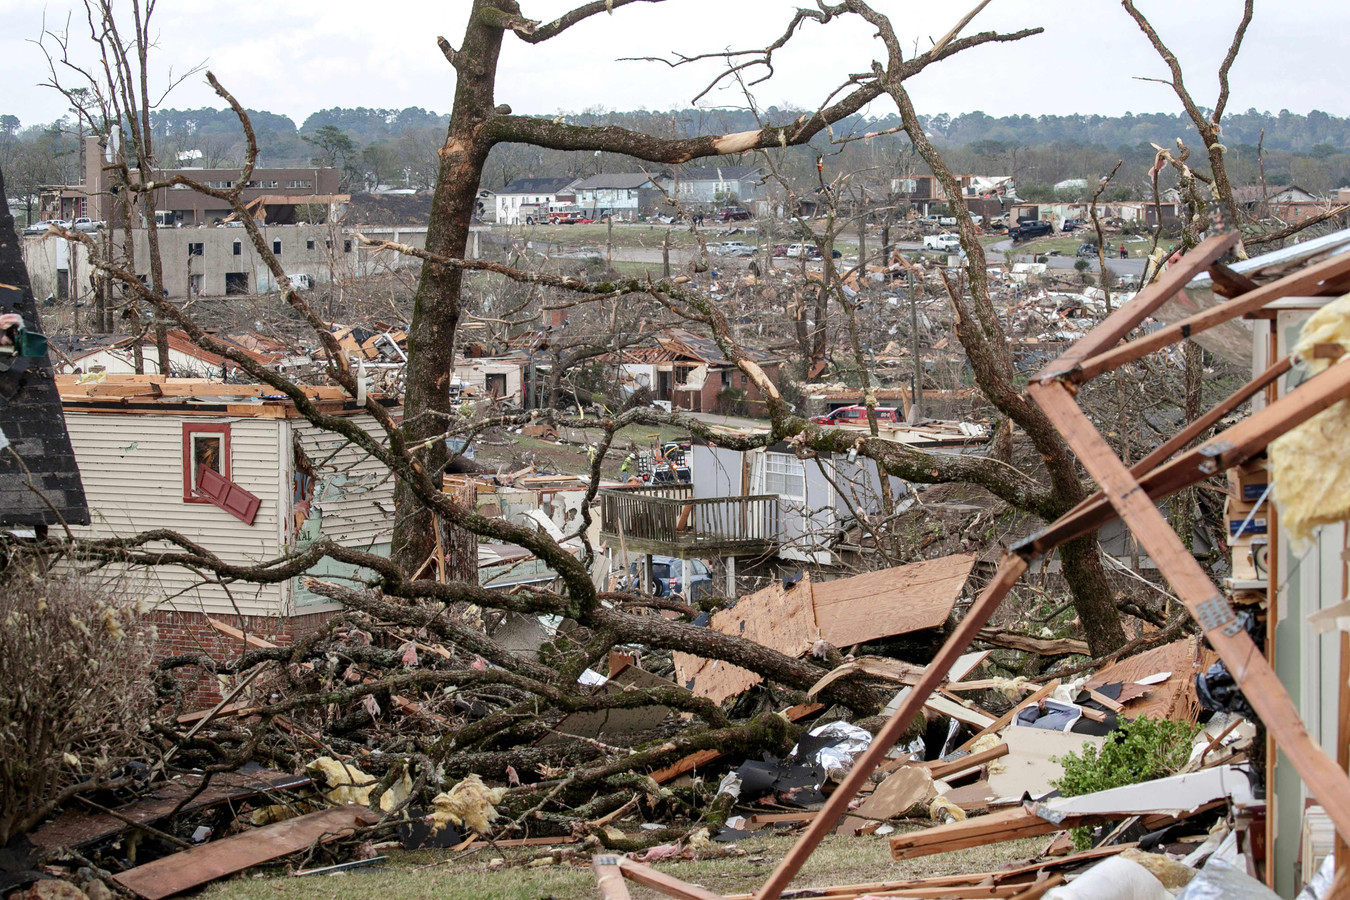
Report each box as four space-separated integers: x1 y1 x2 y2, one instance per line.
0 573 154 846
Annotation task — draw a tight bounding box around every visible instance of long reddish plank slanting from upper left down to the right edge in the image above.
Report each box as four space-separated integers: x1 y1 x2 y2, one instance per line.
1029 380 1350 852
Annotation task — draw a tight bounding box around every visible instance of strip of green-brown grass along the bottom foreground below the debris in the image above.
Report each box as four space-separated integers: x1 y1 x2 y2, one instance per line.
198 835 1046 900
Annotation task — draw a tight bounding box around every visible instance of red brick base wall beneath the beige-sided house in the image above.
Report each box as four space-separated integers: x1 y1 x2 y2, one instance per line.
142 610 335 707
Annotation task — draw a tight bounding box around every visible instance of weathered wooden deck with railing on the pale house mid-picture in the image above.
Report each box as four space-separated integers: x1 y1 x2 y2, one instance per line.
599 484 782 559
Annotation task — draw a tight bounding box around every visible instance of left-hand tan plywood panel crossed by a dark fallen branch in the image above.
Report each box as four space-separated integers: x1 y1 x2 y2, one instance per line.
672 576 819 703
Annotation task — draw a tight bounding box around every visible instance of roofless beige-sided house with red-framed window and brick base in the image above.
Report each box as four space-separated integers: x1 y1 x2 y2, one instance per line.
57 375 398 669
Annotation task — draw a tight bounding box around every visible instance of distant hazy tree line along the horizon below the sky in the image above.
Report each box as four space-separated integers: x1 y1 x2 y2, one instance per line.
0 107 1350 215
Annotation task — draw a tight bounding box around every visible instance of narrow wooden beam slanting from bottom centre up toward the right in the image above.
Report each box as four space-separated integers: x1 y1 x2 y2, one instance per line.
756 555 1027 900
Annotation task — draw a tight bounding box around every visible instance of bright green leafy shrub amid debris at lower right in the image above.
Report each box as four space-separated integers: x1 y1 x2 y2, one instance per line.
1050 715 1200 850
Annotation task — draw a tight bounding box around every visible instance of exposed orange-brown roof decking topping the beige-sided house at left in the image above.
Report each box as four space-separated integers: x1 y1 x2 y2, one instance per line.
55 375 398 418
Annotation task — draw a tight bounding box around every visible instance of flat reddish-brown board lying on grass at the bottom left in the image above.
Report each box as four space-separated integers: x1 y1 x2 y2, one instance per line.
113 806 378 900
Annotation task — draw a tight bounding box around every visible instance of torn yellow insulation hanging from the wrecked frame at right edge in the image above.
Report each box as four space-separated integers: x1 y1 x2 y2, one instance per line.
1270 296 1350 541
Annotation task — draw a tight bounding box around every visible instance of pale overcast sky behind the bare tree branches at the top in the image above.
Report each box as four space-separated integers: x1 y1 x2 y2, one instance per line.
0 0 1350 132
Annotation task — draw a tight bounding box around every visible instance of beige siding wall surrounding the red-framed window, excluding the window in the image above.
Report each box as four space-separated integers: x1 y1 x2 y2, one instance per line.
66 409 289 615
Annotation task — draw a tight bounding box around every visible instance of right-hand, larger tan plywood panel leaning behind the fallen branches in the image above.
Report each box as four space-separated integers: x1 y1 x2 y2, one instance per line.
811 553 976 648
